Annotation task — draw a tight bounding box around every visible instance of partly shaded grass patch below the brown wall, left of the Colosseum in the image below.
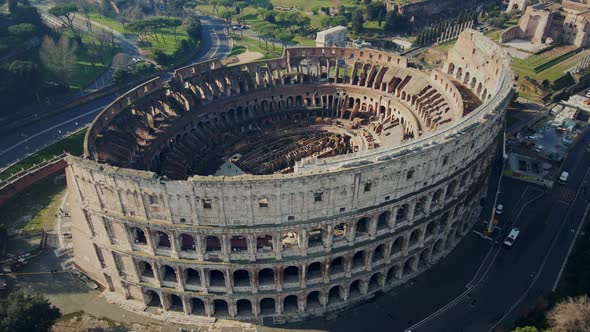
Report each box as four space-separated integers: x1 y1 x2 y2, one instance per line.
0 174 66 230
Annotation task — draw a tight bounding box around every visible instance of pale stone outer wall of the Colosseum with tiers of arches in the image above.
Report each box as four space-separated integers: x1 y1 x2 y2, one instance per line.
66 31 512 322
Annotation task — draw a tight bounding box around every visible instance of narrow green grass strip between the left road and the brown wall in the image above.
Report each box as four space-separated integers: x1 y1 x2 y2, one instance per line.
0 129 86 181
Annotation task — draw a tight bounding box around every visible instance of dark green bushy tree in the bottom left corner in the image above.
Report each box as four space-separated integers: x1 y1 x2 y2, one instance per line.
0 291 61 331
